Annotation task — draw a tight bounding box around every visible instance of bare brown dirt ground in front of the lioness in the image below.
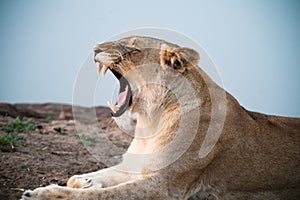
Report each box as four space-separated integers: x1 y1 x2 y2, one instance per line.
0 104 131 200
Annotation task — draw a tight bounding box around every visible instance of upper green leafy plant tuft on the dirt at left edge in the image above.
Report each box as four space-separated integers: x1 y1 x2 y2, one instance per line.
1 117 36 133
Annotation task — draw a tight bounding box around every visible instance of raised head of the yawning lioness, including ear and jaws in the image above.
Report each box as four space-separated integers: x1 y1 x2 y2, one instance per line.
93 36 200 117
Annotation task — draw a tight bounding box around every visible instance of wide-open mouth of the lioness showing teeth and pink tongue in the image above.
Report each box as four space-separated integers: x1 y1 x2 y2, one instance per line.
96 61 132 117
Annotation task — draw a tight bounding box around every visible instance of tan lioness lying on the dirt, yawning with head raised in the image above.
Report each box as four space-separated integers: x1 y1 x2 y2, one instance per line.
22 36 300 200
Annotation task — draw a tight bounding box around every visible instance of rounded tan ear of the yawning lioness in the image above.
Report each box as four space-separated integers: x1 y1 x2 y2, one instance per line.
160 44 200 73
